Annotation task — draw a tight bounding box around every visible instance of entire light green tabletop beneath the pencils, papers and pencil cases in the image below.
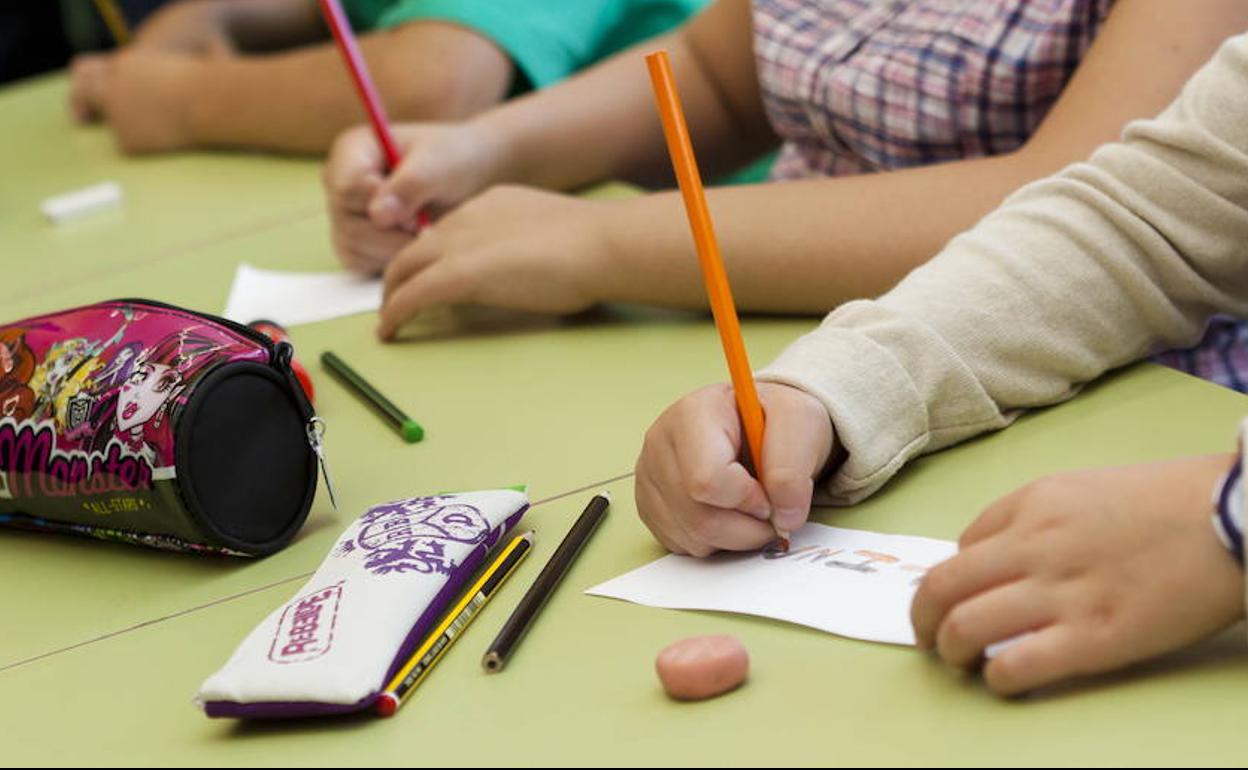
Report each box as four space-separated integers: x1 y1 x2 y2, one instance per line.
0 77 1248 766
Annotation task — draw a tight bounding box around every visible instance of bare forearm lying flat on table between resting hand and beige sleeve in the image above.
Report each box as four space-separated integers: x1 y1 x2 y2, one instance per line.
594 150 1046 313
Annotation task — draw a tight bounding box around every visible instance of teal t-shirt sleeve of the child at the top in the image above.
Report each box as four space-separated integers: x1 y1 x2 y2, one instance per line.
343 0 710 90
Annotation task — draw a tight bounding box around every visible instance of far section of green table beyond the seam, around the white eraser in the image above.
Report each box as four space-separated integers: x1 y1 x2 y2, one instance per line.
0 72 324 305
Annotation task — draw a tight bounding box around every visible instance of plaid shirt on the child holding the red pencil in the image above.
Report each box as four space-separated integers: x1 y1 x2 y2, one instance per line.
754 0 1112 180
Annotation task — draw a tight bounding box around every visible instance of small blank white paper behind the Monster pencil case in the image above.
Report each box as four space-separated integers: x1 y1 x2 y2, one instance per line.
222 262 382 327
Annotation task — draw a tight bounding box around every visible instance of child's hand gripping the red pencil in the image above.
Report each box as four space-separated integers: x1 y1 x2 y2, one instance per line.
322 124 511 273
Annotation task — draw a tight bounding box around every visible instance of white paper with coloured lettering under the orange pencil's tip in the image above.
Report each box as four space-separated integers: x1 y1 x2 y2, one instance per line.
585 523 957 644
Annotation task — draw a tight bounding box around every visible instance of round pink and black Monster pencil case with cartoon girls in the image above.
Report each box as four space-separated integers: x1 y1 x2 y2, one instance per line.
0 300 321 555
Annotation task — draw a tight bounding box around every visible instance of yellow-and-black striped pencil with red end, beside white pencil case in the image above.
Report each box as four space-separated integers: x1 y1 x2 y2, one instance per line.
377 532 533 716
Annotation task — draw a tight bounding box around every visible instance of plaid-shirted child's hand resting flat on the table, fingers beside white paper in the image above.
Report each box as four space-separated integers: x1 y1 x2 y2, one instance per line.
377 187 605 339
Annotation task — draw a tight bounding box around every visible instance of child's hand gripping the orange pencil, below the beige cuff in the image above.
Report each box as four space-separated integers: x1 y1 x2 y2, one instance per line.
634 382 835 557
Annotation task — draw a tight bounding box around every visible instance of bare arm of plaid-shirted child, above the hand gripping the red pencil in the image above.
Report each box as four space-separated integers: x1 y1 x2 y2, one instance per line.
478 0 775 190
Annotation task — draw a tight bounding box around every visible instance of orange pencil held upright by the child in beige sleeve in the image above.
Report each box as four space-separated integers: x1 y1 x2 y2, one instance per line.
645 51 789 549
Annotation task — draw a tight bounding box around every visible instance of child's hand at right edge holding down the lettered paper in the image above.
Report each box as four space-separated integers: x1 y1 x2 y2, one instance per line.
911 456 1244 695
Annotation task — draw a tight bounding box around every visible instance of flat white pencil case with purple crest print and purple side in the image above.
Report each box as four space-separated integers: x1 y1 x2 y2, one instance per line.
195 489 528 719
